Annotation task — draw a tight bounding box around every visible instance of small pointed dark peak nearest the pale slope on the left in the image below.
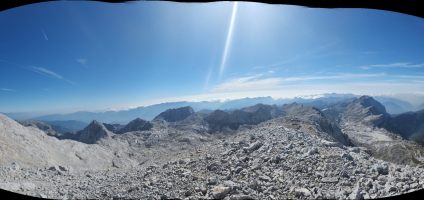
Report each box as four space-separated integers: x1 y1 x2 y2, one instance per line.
76 120 112 144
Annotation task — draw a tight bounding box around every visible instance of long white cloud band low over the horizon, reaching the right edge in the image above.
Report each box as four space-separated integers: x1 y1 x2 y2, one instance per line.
150 82 424 105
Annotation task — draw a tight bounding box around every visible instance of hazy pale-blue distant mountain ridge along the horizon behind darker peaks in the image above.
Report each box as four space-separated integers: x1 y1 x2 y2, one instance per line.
2 93 418 124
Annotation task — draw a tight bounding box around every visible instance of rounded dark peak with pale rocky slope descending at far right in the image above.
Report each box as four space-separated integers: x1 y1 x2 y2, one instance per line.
340 96 424 165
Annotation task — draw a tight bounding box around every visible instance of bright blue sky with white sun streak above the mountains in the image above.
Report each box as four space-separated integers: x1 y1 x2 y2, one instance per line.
0 1 424 113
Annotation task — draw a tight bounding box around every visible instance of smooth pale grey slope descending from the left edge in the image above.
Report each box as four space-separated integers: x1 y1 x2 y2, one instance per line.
0 114 114 169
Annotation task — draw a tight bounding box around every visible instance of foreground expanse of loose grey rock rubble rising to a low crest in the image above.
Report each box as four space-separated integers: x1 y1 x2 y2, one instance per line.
0 117 424 199
